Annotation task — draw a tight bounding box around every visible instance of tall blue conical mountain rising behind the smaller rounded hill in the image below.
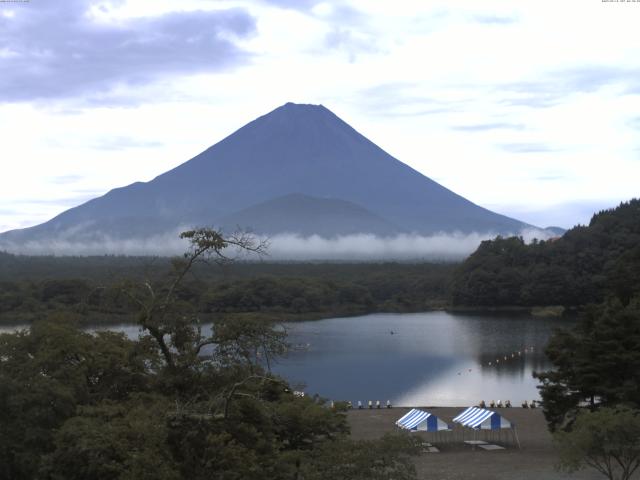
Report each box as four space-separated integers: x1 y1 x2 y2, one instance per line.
0 103 525 241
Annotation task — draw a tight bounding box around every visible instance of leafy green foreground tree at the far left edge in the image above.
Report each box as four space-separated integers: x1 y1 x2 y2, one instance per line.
0 315 154 480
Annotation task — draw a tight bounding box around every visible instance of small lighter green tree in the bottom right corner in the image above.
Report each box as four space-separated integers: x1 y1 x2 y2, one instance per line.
554 407 640 480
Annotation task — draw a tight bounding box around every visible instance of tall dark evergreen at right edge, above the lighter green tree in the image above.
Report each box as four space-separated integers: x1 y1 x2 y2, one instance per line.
535 299 640 430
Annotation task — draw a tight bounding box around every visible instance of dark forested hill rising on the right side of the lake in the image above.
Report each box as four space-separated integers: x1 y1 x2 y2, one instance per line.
451 199 640 306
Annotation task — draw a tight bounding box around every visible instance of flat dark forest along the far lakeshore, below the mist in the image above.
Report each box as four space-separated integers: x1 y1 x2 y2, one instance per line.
0 254 455 323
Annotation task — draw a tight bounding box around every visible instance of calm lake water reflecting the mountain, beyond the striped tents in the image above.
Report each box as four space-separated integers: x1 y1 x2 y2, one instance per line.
274 312 573 406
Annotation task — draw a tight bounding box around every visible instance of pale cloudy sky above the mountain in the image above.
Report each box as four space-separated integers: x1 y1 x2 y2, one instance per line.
0 0 640 232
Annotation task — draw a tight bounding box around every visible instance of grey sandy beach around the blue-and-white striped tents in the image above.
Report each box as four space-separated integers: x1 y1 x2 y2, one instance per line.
347 407 608 480
